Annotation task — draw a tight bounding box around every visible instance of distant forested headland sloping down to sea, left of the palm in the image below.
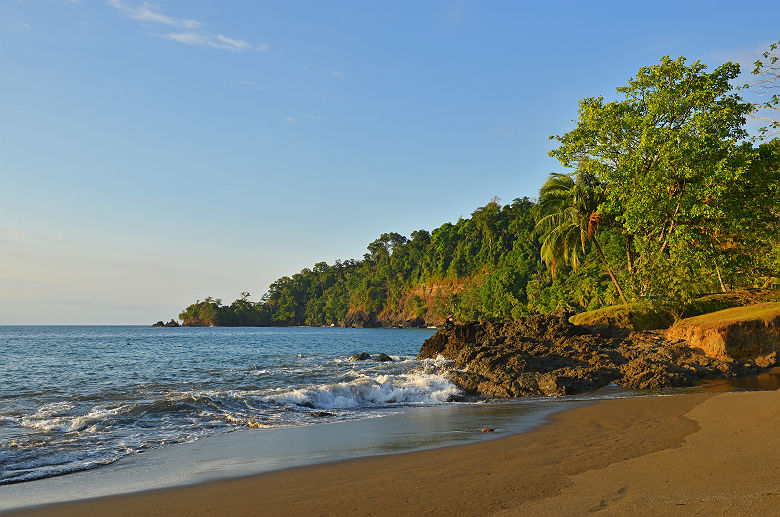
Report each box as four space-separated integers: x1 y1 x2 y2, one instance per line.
180 198 596 326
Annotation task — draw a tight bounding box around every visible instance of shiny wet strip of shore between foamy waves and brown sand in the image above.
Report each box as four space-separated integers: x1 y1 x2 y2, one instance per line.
0 393 592 513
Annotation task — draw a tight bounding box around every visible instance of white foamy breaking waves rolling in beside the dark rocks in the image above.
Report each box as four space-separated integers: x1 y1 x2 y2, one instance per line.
0 355 463 485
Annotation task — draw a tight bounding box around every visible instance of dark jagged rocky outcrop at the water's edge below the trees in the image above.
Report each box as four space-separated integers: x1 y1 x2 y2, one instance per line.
417 315 772 397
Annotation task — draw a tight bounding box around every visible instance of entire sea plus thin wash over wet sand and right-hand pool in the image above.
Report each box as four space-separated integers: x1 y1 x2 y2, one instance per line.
0 326 780 511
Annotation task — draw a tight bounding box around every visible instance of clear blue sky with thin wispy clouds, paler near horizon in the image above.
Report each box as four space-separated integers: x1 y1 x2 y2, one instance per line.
0 0 780 324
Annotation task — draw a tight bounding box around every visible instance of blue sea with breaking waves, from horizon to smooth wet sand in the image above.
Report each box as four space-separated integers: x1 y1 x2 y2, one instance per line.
0 326 444 484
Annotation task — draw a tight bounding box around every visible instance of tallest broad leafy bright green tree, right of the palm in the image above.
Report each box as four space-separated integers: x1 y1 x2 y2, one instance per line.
550 56 767 306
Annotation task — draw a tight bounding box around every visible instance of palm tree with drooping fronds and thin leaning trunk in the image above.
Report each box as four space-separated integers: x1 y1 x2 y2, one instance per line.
534 170 628 304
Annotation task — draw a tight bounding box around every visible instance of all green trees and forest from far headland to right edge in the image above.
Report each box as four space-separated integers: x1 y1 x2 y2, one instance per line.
179 52 780 326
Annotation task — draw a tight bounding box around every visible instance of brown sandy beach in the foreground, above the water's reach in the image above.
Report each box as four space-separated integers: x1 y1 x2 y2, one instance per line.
10 391 780 517
